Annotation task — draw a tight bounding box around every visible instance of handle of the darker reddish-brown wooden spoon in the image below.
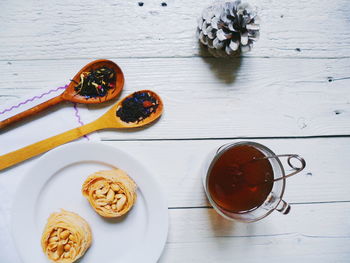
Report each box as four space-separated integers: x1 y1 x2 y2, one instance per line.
0 94 64 130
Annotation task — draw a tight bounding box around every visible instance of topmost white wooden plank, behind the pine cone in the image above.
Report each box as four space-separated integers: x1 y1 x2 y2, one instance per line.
0 0 350 60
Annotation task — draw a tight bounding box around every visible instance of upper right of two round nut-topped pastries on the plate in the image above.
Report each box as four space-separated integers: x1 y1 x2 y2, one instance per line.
82 169 137 217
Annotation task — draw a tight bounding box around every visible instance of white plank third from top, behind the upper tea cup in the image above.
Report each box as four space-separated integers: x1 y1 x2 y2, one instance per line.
105 138 350 209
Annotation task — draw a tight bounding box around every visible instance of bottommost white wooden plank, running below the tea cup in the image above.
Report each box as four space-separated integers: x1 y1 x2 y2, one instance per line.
160 203 350 263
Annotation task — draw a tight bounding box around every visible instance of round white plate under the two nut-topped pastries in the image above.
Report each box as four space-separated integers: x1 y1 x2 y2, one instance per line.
12 143 168 263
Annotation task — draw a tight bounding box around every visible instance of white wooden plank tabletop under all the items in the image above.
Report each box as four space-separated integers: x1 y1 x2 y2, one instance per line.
0 0 350 263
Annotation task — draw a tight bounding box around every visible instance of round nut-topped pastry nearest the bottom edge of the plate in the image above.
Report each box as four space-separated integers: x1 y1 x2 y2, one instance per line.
41 209 92 263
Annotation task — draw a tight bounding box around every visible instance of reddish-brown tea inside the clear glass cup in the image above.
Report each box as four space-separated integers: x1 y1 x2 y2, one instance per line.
208 145 274 213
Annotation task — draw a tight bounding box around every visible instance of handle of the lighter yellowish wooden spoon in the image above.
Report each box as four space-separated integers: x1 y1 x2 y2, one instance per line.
0 120 104 171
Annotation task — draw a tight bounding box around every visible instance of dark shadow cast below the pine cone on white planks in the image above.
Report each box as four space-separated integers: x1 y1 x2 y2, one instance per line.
199 45 242 84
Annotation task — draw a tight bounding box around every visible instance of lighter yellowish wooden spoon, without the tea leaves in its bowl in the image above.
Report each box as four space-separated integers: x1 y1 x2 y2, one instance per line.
0 90 163 170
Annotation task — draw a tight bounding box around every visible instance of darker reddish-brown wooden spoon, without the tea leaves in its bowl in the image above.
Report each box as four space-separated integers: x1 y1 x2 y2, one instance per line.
0 59 124 129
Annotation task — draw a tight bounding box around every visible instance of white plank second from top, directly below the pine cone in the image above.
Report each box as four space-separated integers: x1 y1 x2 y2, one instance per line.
0 58 350 140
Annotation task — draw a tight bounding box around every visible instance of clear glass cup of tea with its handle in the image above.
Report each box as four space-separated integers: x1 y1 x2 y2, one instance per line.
202 141 306 222
